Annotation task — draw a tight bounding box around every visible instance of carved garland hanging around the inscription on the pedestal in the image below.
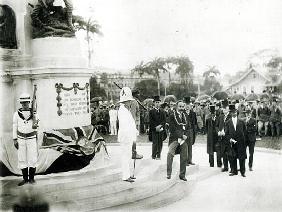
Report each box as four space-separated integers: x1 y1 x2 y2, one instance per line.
55 83 90 116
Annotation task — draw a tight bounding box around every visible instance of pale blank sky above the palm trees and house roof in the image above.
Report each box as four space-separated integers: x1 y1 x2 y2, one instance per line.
73 0 282 75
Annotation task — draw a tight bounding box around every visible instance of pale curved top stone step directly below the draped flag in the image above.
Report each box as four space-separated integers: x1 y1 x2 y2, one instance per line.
0 159 152 195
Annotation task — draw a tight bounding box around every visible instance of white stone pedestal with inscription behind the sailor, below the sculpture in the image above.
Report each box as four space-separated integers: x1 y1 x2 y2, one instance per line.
0 37 97 174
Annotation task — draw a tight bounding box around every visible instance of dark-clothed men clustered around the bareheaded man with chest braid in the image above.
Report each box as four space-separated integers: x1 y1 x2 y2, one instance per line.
149 96 197 181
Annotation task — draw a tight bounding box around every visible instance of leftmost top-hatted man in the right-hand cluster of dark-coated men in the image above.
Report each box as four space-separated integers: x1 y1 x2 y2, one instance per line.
206 105 222 167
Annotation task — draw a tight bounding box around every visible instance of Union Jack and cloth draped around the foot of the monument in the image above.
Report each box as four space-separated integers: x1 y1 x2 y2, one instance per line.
0 125 108 176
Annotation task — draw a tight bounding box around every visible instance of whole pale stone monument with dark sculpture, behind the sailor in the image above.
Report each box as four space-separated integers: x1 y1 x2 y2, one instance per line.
0 0 104 174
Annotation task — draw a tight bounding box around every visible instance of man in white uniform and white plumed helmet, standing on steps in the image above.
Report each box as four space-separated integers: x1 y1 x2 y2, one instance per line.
118 87 138 183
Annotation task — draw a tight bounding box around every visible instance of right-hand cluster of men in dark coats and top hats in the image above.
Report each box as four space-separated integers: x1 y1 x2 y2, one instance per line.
206 100 256 177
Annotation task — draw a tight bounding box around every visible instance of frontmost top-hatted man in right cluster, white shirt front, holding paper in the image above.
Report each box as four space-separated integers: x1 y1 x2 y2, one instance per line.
225 104 247 177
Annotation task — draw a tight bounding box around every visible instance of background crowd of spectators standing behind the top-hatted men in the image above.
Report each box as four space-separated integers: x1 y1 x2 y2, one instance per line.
91 91 282 140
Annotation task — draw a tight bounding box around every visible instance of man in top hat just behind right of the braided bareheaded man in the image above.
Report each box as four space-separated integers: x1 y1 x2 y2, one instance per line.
184 96 197 166
